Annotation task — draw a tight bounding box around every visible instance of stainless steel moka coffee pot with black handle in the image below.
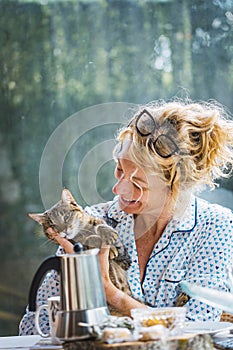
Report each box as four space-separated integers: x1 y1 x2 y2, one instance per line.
29 248 109 340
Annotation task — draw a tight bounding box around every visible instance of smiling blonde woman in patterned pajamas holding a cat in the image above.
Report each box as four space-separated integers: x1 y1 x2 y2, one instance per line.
21 101 233 334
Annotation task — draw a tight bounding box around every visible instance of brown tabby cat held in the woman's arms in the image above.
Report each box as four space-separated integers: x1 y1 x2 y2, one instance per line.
28 189 131 315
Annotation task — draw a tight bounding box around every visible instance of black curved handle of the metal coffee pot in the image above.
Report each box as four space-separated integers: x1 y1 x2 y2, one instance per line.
28 256 61 311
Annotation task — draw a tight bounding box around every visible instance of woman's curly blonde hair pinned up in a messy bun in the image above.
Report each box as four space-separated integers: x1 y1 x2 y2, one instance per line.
114 100 233 205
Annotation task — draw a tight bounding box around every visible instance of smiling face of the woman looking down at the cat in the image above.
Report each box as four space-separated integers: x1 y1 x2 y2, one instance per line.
113 141 170 217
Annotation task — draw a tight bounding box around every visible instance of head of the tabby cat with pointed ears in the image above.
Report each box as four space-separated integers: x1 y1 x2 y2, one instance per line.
28 189 84 240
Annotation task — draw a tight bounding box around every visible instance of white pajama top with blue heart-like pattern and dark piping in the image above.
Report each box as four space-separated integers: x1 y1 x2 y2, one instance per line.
19 196 233 335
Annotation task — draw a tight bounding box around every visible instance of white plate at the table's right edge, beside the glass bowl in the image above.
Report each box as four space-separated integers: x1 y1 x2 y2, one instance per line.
183 321 233 334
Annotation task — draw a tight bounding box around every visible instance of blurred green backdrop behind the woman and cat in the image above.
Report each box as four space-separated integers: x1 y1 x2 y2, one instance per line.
0 0 233 335
